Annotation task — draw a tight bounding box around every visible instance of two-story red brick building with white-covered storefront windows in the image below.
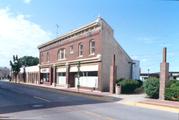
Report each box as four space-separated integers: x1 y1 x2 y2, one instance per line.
38 17 138 91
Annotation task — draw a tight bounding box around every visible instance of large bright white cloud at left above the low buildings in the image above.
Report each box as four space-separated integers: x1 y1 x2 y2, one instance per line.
0 8 51 66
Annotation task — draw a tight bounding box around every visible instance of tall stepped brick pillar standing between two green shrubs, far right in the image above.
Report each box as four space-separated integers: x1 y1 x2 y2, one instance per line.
159 48 169 100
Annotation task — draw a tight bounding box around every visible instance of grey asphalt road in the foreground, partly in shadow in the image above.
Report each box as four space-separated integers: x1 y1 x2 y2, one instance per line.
0 82 179 120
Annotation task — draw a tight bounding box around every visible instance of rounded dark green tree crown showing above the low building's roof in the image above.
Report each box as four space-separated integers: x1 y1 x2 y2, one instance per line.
20 56 39 66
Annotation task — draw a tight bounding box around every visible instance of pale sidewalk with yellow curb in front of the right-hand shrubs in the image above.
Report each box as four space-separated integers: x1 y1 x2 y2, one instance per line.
117 94 179 113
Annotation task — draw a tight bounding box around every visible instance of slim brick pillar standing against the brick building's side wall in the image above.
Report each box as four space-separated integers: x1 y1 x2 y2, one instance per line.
109 55 117 94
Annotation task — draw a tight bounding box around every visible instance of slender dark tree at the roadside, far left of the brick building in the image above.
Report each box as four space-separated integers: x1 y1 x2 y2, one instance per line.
10 55 21 82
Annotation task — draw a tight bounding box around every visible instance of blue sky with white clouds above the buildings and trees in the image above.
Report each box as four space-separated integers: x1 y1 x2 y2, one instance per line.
0 0 179 72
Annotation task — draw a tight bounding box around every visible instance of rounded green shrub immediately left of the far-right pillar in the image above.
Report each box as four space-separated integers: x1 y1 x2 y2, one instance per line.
144 77 159 98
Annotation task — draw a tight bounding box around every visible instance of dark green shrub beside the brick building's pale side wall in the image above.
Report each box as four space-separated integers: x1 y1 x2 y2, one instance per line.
117 80 139 94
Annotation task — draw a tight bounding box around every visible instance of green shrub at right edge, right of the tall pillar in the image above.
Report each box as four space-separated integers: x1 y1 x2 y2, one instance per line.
165 87 179 101
